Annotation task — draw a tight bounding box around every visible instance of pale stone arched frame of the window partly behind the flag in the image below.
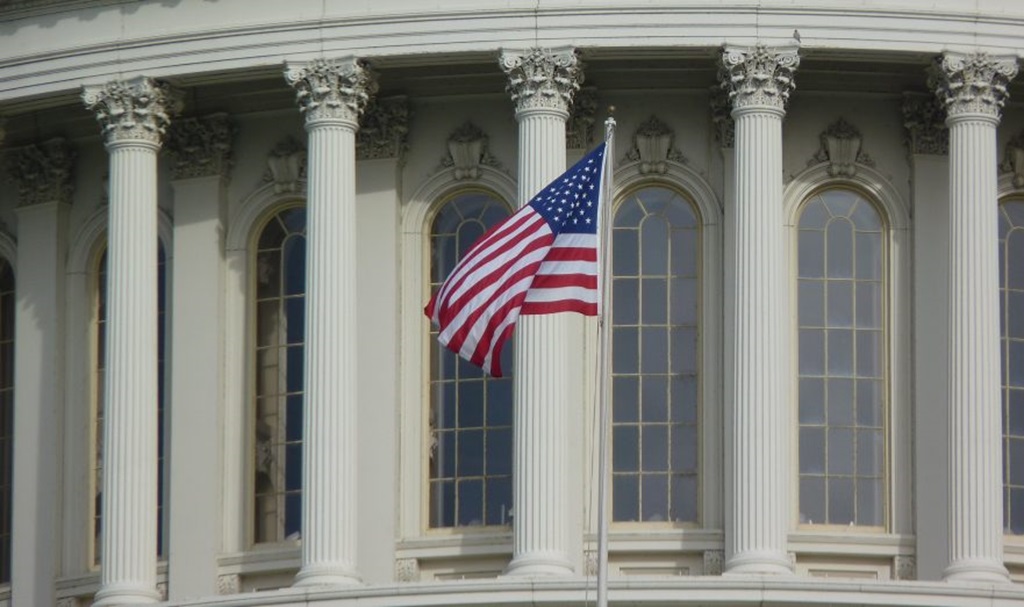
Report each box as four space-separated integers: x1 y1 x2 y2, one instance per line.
396 166 516 558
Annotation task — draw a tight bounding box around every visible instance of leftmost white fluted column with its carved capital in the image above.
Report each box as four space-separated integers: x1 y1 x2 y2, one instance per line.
82 78 178 606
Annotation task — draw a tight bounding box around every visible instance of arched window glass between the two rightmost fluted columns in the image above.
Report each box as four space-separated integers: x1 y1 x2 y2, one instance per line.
797 188 888 527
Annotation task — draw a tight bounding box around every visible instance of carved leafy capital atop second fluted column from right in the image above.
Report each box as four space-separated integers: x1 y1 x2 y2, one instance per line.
719 44 800 110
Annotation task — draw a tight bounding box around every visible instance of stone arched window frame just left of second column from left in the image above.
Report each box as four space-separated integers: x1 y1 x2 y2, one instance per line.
222 181 306 556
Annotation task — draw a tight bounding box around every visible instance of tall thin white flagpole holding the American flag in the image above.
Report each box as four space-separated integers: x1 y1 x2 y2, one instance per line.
597 111 615 607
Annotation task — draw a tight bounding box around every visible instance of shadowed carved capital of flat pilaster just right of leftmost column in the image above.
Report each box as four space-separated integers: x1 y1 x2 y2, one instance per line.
164 114 236 179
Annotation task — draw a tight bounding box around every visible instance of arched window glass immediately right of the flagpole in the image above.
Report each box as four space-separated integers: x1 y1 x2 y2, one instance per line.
611 186 701 522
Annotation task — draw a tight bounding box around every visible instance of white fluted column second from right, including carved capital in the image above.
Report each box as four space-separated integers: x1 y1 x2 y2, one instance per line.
721 46 800 573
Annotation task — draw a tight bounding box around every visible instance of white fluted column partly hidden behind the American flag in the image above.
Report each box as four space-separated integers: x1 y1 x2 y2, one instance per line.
501 48 583 575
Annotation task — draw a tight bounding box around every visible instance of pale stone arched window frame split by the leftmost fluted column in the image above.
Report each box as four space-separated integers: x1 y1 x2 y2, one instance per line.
61 206 174 575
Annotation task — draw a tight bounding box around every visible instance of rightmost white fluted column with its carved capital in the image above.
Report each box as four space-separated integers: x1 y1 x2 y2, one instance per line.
932 52 1017 582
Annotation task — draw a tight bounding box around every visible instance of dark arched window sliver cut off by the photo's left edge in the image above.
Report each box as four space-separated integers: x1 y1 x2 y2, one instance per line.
0 259 14 583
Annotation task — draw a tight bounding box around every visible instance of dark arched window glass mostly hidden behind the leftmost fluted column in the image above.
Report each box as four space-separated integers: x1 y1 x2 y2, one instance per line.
92 244 169 564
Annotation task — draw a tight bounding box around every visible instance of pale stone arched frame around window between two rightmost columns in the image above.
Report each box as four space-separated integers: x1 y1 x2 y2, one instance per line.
778 164 913 556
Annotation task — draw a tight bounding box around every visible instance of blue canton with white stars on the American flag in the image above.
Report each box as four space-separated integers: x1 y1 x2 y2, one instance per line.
529 144 604 234
